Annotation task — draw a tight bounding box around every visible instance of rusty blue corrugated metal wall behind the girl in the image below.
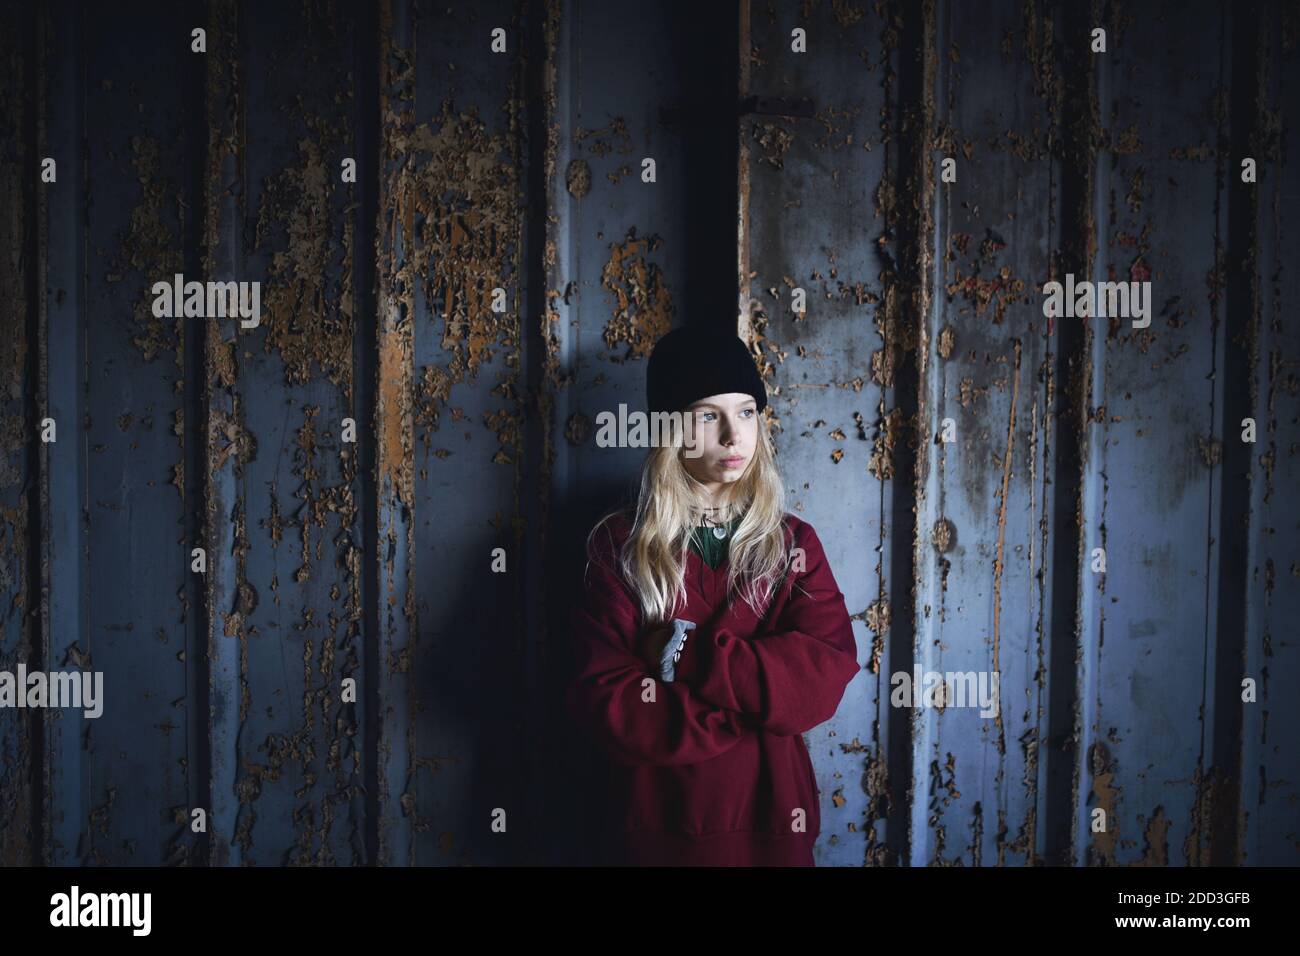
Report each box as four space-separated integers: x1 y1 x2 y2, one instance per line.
0 0 1300 865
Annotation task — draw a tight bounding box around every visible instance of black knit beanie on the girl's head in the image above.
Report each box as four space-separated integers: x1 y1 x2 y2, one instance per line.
646 325 767 412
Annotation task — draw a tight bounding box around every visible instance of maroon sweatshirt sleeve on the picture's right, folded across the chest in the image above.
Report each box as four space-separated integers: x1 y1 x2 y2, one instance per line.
694 524 859 736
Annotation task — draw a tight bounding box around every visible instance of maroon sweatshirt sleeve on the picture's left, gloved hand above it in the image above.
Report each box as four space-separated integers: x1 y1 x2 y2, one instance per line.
566 528 754 766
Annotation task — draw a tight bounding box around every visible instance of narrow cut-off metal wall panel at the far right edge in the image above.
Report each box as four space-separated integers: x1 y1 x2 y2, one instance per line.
1223 4 1300 866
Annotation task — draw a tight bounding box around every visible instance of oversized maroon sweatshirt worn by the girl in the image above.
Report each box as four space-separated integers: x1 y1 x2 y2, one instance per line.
567 514 858 866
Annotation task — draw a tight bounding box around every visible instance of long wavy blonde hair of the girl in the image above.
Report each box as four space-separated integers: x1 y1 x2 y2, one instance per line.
588 420 789 626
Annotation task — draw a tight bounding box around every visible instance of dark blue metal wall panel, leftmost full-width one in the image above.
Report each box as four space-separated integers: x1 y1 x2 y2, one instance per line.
44 1 196 864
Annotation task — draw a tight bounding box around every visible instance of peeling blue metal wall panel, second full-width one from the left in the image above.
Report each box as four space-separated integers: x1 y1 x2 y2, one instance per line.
218 4 367 865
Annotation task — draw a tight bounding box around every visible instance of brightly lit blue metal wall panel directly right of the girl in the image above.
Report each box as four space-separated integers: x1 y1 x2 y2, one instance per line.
740 5 910 865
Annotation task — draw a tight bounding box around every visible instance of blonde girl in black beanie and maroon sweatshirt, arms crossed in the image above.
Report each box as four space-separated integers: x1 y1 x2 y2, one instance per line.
567 326 858 866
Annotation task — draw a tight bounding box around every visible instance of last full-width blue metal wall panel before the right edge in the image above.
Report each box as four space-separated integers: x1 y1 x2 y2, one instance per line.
1075 4 1227 865
